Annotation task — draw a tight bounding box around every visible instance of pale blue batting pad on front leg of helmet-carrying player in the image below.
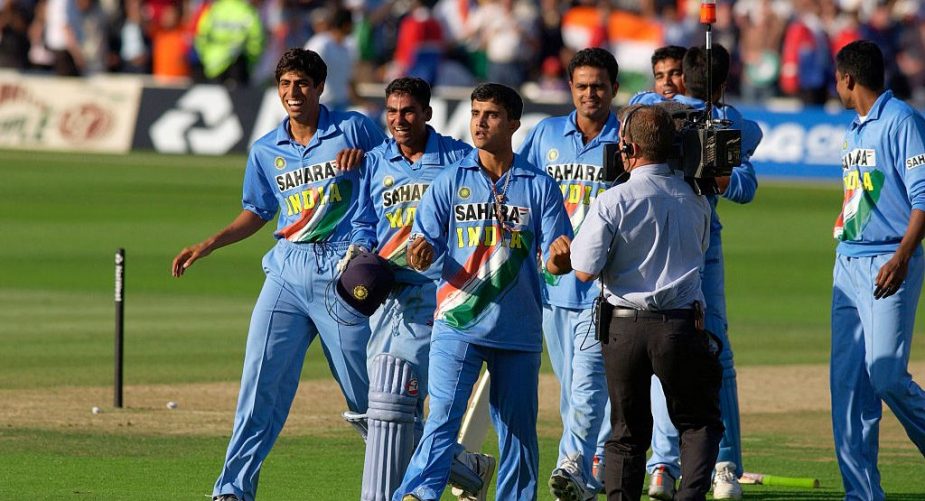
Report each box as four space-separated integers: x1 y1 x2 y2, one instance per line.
361 353 418 501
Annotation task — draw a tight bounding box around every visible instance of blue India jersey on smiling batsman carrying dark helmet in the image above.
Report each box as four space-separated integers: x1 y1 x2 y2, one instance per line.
351 125 472 284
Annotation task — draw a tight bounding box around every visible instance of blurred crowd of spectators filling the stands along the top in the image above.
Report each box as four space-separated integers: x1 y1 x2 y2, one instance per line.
0 0 925 107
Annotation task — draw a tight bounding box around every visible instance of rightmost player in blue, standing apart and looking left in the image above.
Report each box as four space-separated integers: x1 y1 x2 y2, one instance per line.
829 40 925 501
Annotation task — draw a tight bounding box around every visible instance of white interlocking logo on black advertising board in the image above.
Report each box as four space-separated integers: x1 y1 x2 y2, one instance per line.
150 85 244 155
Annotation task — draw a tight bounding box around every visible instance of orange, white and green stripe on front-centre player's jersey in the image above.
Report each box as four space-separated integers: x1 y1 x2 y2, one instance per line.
435 225 533 329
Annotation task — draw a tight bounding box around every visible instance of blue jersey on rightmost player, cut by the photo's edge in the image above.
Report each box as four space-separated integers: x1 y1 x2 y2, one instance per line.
834 91 925 257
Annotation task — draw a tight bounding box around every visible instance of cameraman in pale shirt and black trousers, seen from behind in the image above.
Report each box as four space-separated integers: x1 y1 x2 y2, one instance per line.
556 106 723 501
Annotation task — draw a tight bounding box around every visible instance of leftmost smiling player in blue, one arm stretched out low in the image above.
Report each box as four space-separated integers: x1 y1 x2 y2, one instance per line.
172 49 385 501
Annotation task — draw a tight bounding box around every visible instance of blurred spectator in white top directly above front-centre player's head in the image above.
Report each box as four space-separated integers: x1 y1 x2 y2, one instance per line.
466 0 538 89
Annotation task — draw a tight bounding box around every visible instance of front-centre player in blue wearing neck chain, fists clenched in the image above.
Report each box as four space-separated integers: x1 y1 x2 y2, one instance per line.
393 83 572 501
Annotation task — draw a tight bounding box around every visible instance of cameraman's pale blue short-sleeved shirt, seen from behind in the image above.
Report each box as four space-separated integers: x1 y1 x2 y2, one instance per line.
571 164 710 310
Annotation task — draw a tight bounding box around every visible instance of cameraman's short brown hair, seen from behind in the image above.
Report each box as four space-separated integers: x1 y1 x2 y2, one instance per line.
620 105 675 163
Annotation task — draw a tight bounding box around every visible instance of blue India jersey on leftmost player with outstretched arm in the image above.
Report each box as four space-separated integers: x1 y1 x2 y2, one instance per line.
242 105 385 242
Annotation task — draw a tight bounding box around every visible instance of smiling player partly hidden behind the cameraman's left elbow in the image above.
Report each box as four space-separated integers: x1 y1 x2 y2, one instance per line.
520 48 620 501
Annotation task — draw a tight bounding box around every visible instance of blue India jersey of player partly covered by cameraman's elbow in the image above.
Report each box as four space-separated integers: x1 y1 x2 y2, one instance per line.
519 111 620 309
